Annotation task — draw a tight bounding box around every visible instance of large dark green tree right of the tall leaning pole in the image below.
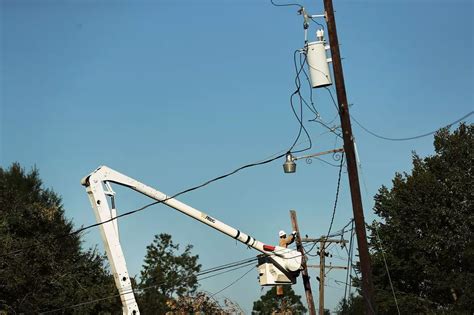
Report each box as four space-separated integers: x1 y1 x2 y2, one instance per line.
346 124 474 314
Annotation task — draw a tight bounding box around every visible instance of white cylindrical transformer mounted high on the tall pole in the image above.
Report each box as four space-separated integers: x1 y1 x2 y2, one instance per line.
306 40 332 88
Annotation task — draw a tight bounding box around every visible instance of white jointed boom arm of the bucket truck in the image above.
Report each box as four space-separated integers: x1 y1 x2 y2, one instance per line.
81 166 301 314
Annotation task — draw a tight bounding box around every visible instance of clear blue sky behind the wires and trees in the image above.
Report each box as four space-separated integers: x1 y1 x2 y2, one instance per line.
0 0 474 313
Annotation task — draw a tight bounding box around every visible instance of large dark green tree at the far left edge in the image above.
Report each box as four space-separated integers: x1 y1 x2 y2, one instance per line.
0 163 120 314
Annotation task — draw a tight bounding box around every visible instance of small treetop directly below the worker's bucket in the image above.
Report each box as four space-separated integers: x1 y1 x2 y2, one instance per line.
252 285 306 314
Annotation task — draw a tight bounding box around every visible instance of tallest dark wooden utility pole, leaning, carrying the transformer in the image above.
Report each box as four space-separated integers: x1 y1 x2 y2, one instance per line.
323 0 376 314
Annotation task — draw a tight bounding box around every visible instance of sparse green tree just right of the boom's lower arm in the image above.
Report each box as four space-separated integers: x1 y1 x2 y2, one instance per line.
139 234 201 314
